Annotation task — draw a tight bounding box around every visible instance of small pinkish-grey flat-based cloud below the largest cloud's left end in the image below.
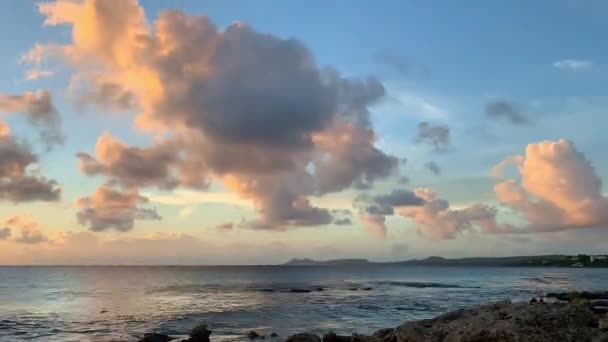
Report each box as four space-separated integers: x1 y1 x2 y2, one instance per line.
76 185 161 232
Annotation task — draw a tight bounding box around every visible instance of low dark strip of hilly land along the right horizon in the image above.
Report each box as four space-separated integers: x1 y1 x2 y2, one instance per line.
283 254 608 267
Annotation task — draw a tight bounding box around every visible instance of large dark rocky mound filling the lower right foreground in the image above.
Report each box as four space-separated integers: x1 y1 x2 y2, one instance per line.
376 302 608 342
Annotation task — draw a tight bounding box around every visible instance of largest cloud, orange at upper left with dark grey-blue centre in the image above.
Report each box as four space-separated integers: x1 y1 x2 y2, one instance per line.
29 0 398 230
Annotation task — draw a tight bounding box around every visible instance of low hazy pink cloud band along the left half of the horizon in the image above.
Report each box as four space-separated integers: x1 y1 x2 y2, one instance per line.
0 231 310 265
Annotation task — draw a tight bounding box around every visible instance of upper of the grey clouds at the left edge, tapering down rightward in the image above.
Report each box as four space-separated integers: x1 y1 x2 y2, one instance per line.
0 90 65 147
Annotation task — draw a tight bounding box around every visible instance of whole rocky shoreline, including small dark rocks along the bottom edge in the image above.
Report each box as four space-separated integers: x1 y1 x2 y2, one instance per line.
140 292 608 342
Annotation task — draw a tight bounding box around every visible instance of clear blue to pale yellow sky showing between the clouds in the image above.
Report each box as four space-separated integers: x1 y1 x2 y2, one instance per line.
0 0 608 263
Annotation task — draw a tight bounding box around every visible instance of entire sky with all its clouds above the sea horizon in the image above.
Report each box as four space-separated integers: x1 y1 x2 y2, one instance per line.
0 0 608 264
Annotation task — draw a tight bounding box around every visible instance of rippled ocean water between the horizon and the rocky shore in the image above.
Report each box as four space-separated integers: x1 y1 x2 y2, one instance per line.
0 266 608 341
